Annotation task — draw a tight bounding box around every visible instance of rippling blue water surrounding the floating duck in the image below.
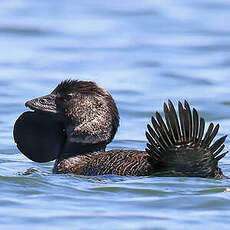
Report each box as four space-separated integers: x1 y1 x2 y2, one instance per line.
0 0 230 230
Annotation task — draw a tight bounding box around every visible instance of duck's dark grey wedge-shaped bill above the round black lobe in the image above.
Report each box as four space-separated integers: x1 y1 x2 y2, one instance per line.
25 94 58 114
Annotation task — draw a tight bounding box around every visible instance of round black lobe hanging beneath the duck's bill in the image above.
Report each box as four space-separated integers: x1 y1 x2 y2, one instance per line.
13 111 65 162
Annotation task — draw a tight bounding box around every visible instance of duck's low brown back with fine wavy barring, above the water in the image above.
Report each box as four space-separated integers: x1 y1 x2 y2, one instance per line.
57 150 153 176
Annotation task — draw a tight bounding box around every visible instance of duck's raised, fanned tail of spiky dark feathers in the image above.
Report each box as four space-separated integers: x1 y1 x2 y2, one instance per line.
146 100 227 178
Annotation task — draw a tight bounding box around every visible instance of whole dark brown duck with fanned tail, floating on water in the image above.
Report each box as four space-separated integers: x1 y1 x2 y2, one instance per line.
13 79 228 178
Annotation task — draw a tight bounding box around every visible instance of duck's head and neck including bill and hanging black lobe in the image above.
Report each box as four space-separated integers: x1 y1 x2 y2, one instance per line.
14 80 119 162
